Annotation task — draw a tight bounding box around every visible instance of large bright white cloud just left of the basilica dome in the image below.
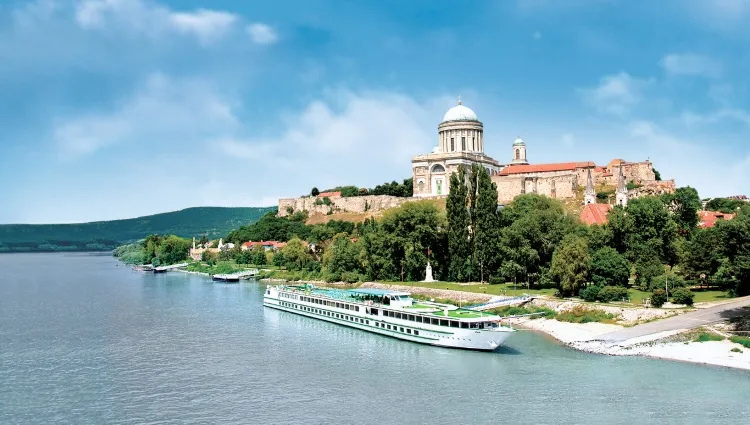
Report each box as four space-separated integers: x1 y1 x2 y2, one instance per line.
216 91 454 196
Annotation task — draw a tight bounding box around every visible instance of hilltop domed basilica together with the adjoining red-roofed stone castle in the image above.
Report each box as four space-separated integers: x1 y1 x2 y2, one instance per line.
412 99 674 203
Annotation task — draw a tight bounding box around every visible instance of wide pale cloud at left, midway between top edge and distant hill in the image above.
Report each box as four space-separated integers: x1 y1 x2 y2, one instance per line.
53 74 237 159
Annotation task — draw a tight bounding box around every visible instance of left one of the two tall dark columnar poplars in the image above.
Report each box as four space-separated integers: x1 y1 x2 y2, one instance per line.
445 165 471 282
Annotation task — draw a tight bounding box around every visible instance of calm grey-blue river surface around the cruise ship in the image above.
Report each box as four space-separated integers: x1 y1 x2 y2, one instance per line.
0 254 750 425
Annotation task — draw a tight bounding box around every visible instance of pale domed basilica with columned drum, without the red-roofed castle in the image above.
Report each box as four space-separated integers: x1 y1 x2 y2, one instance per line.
411 99 503 197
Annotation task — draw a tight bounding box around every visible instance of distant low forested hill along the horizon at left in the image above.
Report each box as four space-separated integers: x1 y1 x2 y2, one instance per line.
0 207 275 252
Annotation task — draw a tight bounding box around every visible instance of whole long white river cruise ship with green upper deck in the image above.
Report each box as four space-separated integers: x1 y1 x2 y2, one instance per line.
263 285 516 351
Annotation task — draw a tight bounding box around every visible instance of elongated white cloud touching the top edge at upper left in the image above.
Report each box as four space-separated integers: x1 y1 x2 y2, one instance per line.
75 0 239 44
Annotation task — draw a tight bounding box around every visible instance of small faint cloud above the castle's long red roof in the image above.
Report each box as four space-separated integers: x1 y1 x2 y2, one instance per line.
578 72 653 116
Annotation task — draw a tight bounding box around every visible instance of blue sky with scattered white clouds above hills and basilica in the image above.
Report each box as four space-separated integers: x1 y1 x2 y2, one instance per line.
0 0 750 223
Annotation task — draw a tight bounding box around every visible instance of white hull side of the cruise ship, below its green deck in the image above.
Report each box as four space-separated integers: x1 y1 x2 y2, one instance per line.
263 288 516 351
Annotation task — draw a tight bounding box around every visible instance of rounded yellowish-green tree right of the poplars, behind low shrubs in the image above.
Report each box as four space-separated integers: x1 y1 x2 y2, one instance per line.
550 235 589 296
